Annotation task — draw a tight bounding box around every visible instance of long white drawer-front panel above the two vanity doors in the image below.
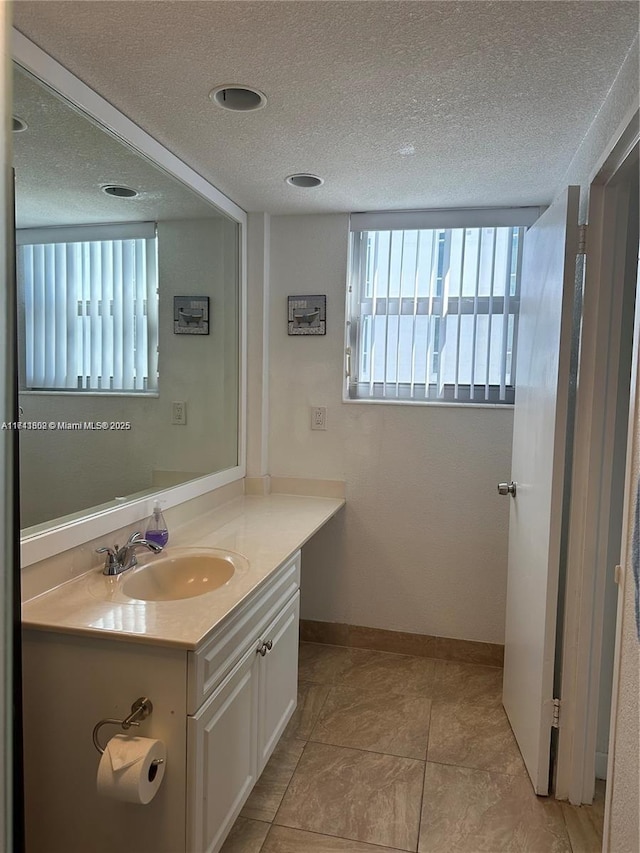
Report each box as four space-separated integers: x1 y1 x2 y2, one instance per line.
187 551 300 714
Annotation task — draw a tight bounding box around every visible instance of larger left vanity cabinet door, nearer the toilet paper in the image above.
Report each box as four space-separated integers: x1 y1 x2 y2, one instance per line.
187 645 260 853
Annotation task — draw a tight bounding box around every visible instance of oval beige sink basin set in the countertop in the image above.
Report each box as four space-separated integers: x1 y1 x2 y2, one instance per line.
120 548 249 601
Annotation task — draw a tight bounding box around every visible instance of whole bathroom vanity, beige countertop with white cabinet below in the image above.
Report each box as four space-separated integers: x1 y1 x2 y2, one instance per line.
23 495 344 853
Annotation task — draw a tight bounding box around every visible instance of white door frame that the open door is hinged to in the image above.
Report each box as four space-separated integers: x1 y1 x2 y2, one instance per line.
555 112 640 805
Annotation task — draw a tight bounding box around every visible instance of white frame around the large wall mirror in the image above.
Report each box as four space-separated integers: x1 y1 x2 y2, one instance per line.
11 27 247 567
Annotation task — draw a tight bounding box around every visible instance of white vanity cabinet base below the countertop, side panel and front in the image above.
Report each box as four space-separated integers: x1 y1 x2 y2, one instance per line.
24 552 300 853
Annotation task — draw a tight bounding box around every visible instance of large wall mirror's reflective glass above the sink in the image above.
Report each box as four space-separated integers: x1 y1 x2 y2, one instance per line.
13 66 239 534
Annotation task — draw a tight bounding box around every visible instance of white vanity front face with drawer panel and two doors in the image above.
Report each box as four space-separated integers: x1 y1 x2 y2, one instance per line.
187 553 300 853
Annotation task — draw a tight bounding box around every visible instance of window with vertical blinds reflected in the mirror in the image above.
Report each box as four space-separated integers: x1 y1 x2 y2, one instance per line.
17 223 158 393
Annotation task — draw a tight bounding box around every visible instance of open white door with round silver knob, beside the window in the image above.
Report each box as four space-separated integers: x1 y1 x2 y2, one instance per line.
503 187 580 794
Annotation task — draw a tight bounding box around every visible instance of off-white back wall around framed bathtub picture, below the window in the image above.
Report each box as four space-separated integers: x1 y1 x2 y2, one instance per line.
269 215 512 643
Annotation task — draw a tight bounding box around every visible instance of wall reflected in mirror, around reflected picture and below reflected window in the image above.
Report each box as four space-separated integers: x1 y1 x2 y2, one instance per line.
20 218 238 527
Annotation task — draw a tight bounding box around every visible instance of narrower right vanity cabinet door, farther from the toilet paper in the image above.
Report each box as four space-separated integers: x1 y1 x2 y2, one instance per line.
258 592 300 774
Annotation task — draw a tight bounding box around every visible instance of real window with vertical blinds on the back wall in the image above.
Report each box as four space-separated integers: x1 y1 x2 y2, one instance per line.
347 208 538 404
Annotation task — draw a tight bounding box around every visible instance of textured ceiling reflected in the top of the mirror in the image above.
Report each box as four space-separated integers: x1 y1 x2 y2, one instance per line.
13 70 218 228
